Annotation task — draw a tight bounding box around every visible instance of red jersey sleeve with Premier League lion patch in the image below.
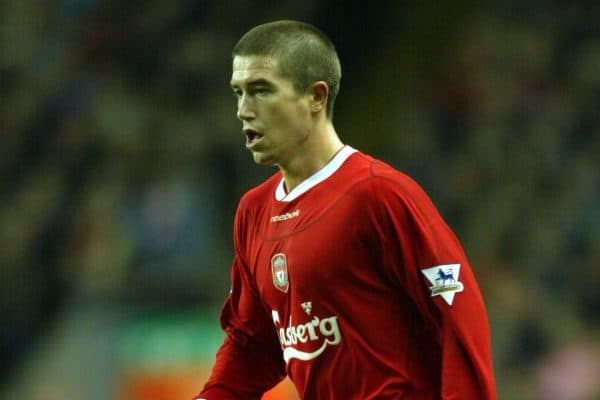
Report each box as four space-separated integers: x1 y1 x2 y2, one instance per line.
378 173 496 400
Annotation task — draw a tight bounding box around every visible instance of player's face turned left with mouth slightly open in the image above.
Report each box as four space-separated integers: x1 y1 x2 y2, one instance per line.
231 56 311 165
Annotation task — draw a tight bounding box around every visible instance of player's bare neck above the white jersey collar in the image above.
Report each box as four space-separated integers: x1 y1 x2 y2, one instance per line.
279 122 344 193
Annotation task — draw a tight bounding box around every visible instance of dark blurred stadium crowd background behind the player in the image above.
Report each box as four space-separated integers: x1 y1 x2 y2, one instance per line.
0 0 600 400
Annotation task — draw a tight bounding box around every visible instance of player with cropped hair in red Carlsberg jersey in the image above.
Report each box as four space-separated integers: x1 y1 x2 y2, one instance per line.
196 21 496 400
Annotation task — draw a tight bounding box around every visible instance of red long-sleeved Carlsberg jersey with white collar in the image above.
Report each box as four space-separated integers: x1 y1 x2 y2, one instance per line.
198 146 496 400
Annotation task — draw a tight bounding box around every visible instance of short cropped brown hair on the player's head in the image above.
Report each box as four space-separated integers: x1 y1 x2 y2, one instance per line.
232 20 342 120
